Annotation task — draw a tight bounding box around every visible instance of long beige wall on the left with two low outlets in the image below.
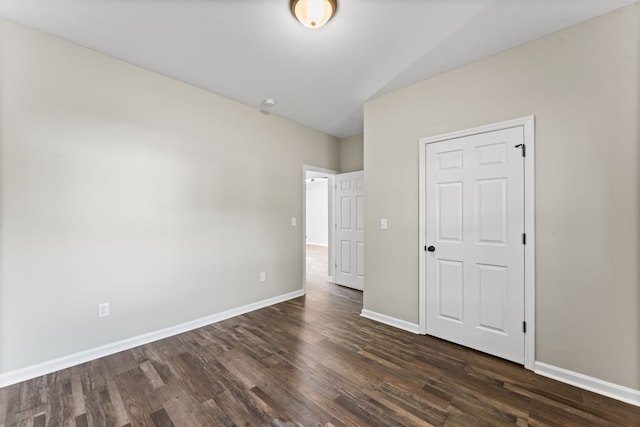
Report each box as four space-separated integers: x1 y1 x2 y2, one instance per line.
0 20 339 374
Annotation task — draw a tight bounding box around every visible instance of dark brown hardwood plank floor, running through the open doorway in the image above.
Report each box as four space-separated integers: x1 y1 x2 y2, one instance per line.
0 247 640 427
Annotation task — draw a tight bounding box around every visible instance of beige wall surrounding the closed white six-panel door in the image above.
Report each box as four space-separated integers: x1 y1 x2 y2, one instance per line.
364 4 640 389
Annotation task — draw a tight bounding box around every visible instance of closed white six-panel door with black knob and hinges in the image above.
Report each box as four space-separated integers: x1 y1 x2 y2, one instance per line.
425 127 525 363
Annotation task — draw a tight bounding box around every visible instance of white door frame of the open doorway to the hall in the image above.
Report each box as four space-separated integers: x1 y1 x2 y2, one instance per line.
301 165 338 292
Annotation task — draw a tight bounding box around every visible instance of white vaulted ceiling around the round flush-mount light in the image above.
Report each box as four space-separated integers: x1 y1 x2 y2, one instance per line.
0 0 638 137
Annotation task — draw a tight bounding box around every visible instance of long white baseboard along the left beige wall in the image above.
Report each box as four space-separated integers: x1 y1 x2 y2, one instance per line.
0 289 304 388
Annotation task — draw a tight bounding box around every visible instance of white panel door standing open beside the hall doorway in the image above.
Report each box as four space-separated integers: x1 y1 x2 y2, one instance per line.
336 171 364 290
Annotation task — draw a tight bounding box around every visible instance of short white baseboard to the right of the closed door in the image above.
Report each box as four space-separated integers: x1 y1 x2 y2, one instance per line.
534 362 640 406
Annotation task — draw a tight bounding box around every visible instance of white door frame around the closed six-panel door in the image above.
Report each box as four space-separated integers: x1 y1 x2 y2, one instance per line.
418 116 536 370
